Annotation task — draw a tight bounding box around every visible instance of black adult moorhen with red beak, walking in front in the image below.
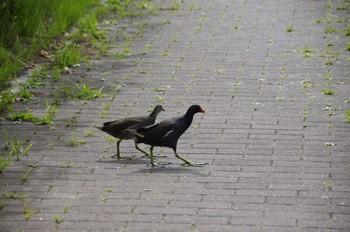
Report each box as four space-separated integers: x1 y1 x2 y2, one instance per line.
131 105 208 167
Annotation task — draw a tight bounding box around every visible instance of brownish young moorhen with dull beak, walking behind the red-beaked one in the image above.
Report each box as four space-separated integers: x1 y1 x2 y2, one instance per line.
97 105 164 159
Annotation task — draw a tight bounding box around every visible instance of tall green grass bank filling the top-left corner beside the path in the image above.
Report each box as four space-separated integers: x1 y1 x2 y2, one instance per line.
0 0 96 89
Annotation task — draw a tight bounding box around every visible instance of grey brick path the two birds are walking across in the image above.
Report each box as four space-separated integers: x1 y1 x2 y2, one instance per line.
0 0 350 232
